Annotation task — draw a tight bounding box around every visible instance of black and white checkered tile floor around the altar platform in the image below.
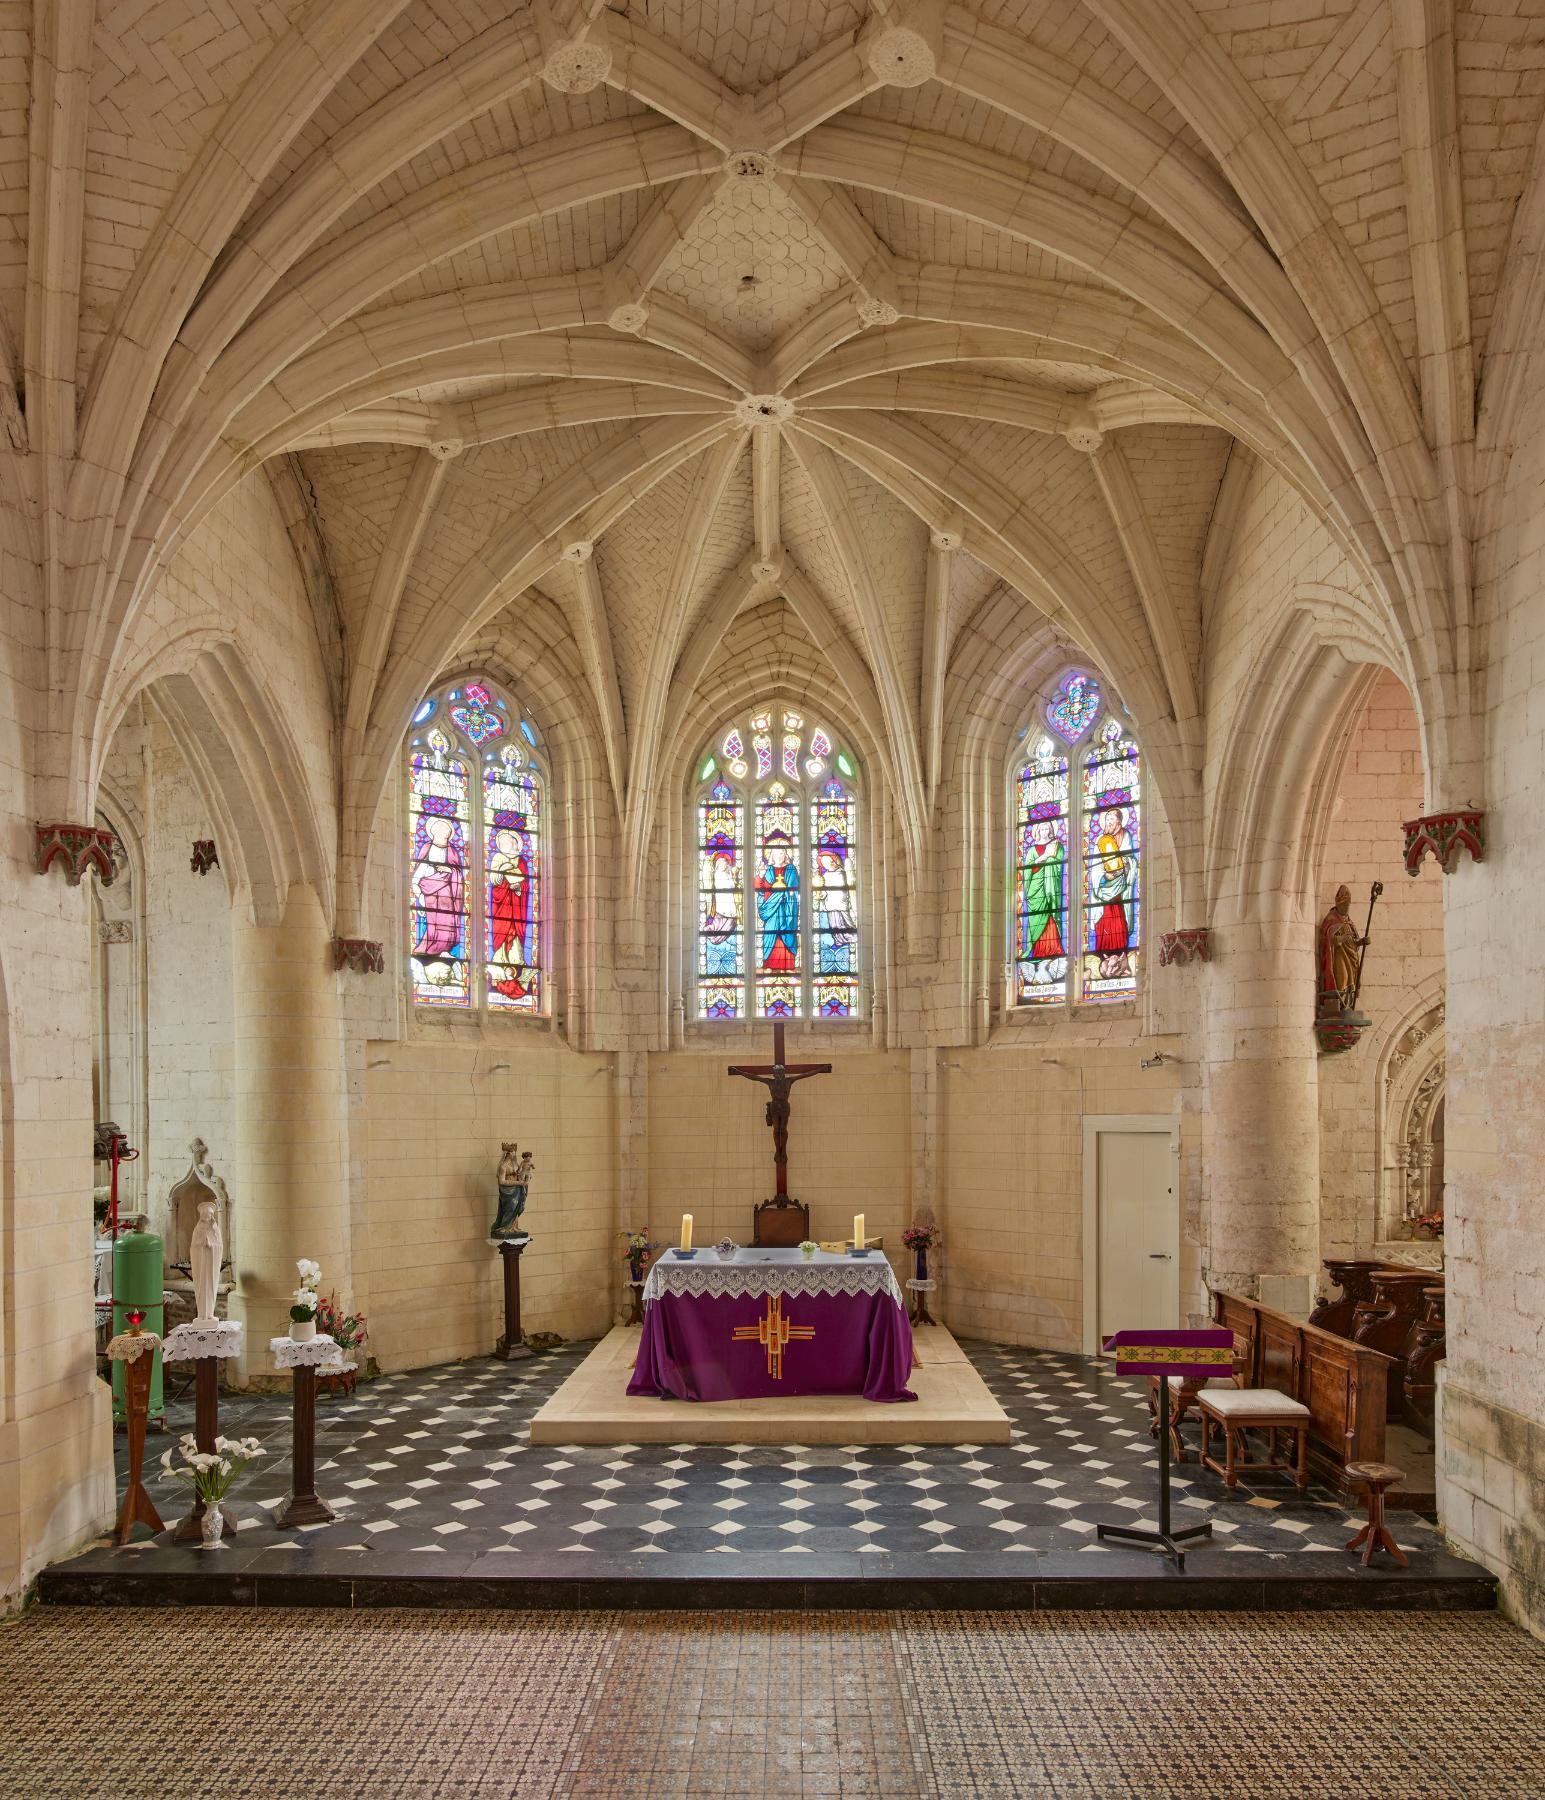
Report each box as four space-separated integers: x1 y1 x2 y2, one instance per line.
105 1345 1439 1559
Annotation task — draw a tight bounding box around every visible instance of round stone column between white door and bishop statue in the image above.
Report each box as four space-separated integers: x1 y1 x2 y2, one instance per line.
1201 916 1320 1316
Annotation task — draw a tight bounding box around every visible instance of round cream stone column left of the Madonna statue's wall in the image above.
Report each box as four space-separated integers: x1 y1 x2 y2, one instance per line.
230 884 351 1379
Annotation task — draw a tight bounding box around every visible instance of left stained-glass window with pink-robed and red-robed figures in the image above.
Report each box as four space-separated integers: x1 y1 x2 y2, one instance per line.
407 682 546 1013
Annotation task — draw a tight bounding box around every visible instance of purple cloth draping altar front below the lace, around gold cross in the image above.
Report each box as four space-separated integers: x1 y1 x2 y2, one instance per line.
628 1294 917 1400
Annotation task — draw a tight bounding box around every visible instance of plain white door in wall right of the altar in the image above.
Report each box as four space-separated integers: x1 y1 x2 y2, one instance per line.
1093 1127 1179 1341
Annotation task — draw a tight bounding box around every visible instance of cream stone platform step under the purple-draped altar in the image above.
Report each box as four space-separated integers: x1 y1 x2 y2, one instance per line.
531 1325 1012 1444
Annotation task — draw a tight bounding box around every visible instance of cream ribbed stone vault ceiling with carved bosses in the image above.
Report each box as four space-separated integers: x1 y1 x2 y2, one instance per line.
12 0 1541 928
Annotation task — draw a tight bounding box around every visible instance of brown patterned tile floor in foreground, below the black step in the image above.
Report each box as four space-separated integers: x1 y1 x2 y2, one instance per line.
0 1607 1545 1800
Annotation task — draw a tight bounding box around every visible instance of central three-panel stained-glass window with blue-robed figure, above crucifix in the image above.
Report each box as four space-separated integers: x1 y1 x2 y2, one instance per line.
693 706 861 1019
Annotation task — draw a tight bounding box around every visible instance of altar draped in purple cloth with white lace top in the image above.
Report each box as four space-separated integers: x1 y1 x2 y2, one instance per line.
628 1249 917 1402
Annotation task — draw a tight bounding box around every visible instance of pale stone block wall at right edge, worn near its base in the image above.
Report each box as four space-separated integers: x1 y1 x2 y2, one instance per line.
1428 365 1545 1633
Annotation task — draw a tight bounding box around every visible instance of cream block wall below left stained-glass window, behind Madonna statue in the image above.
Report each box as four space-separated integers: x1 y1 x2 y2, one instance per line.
363 1030 621 1370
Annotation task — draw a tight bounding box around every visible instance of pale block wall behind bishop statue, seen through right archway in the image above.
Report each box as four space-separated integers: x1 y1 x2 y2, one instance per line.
1318 671 1444 1258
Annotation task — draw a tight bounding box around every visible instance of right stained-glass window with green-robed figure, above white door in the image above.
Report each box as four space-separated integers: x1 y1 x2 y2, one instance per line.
1010 670 1142 1006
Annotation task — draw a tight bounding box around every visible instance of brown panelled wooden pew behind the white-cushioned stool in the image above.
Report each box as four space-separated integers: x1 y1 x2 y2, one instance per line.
1212 1292 1392 1492
